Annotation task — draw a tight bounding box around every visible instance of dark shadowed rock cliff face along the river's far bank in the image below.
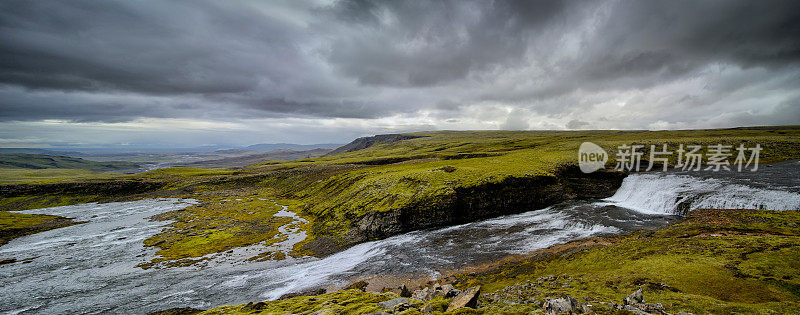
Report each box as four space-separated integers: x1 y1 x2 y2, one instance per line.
344 167 626 246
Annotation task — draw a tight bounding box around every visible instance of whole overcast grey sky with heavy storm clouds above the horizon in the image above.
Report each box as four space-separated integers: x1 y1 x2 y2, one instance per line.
0 0 800 147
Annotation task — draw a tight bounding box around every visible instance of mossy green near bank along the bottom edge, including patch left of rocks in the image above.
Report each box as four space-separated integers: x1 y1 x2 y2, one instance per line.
198 210 800 314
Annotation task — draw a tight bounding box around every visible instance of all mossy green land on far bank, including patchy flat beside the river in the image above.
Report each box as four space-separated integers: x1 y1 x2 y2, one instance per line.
0 127 800 266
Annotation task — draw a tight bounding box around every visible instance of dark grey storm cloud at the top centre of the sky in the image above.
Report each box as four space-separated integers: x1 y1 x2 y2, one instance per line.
324 1 569 86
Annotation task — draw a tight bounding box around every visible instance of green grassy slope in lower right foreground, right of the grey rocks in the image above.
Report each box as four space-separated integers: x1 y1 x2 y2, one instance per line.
464 210 800 314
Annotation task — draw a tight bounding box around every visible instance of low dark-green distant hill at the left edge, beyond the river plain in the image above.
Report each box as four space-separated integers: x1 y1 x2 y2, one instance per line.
0 153 139 172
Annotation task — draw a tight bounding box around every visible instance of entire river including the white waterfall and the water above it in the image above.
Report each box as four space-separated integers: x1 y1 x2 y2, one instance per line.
0 161 800 314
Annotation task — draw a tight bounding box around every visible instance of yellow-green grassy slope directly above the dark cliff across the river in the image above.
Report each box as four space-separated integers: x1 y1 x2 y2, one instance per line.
247 128 800 252
